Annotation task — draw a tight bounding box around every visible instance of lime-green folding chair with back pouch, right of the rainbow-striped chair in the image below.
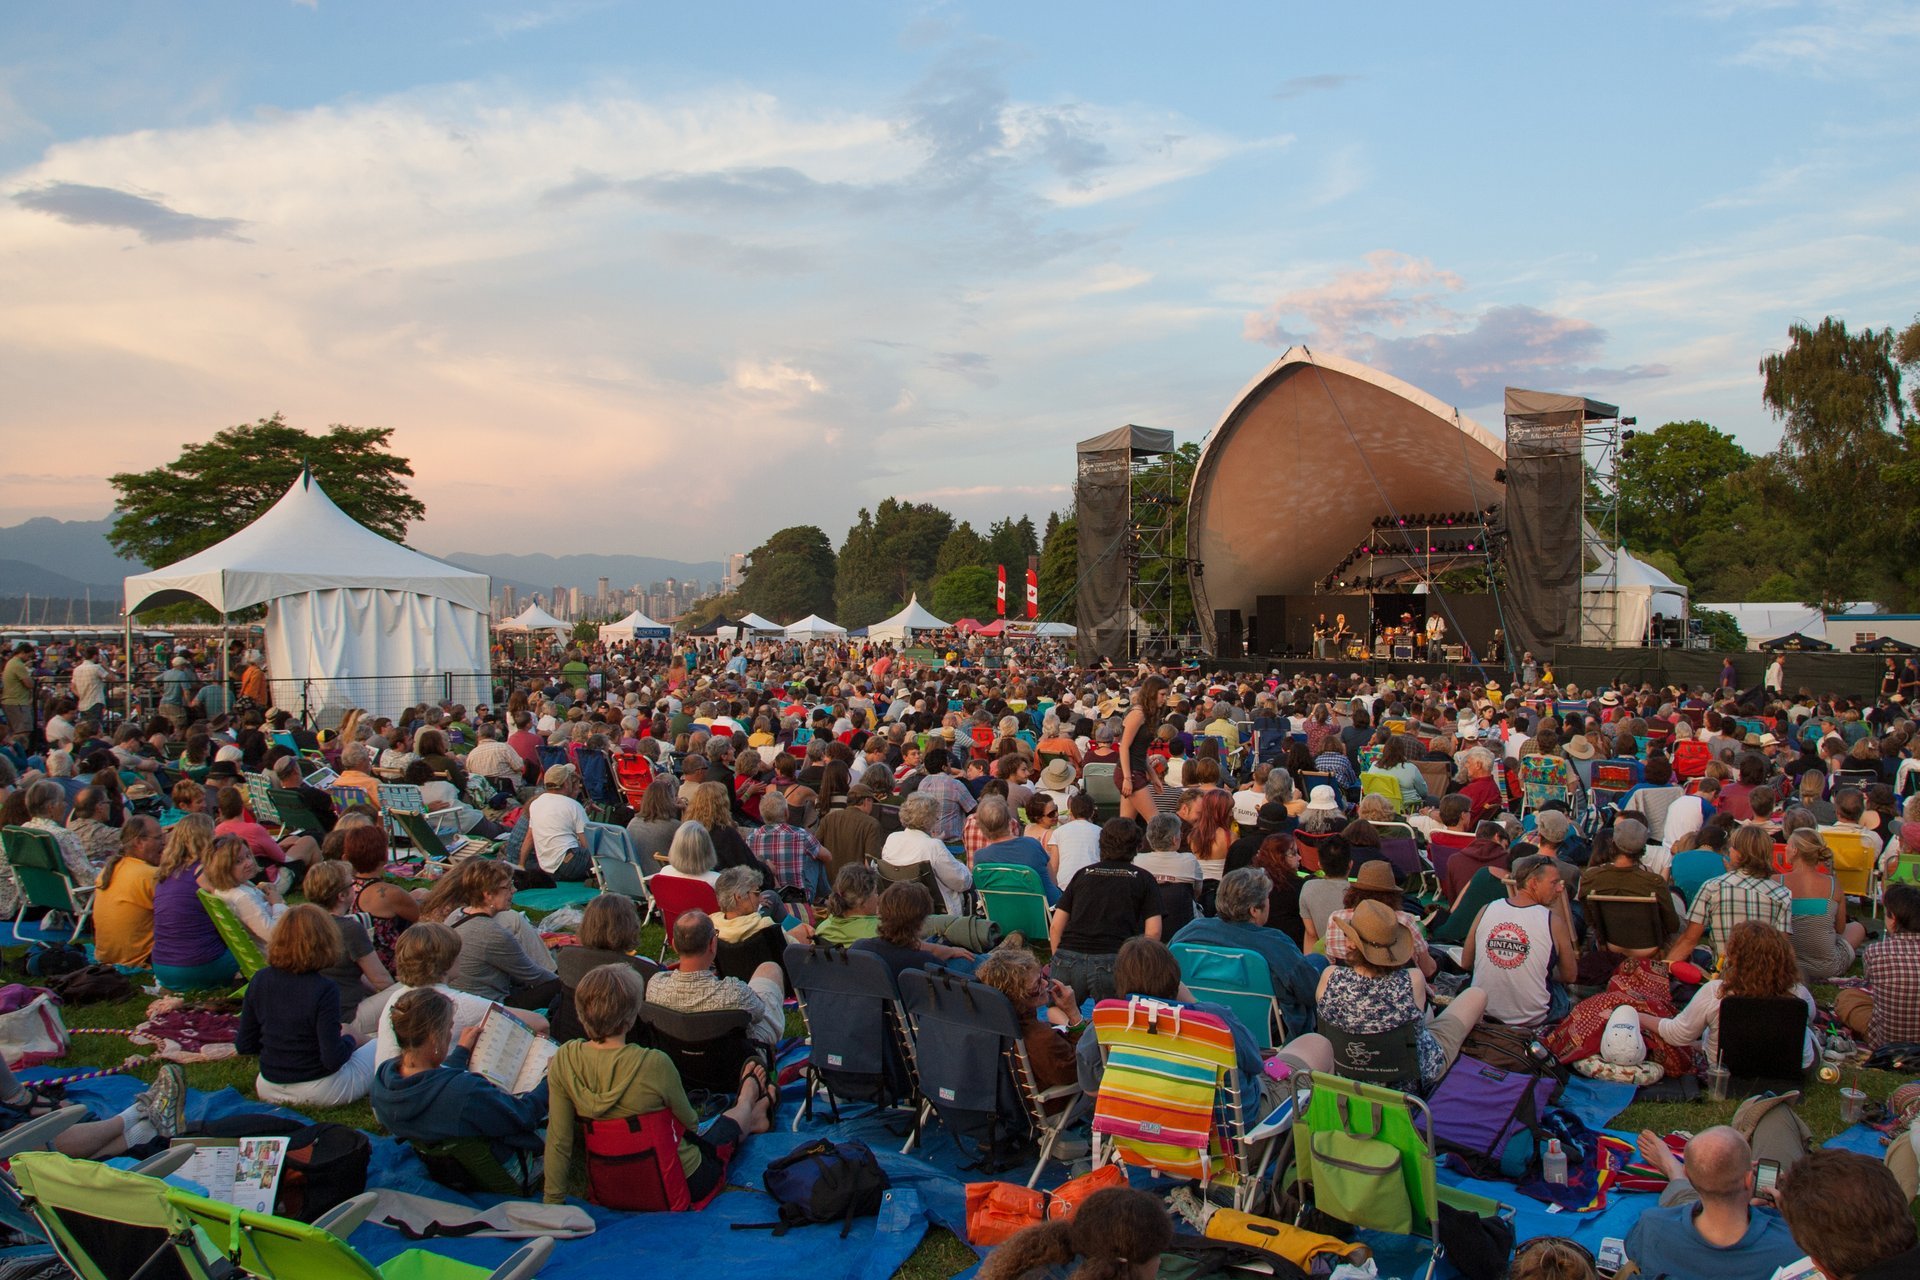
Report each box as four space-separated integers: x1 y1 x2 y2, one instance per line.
1292 1071 1511 1280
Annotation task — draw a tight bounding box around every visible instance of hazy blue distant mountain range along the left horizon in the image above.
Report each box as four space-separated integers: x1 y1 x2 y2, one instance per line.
0 516 724 601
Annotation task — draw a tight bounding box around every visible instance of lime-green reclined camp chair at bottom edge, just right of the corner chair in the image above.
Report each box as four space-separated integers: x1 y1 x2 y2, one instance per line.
167 1186 553 1280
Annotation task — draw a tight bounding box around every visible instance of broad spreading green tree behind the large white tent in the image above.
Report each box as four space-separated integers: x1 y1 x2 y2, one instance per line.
108 415 426 566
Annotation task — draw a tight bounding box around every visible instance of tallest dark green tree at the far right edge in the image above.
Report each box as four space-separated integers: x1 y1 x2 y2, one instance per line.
1761 317 1905 608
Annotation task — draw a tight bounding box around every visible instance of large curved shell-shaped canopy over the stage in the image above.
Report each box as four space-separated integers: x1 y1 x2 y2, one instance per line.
1187 347 1507 647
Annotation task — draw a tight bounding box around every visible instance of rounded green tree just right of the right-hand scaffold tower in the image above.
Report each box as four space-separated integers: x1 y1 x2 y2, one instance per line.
1619 420 1753 558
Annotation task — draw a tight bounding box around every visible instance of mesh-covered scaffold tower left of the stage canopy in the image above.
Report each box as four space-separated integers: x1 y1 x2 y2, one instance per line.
1073 426 1187 666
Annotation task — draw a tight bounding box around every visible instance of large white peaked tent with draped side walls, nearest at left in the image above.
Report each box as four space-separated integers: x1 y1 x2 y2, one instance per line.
127 472 493 714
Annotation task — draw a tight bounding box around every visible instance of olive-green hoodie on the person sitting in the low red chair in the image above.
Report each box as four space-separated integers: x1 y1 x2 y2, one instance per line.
545 1040 701 1205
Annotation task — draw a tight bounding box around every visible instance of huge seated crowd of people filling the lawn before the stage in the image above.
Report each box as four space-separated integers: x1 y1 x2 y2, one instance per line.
0 641 1920 1276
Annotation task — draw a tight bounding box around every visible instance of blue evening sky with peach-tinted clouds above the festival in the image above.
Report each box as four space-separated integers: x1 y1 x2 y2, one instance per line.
0 0 1920 558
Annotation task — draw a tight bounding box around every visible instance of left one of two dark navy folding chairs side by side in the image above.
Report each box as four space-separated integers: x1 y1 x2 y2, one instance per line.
785 944 918 1130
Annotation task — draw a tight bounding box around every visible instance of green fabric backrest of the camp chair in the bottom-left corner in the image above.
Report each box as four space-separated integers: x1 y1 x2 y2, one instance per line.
8 1151 188 1280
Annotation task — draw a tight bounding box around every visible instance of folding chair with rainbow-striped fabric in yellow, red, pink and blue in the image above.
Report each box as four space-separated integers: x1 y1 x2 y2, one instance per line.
1092 996 1261 1213
